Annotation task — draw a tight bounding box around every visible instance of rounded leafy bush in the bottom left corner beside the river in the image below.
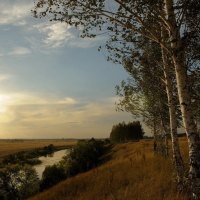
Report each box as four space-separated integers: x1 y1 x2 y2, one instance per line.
0 165 39 200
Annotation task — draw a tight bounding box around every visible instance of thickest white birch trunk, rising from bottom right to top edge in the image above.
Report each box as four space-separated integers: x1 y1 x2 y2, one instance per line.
165 0 200 197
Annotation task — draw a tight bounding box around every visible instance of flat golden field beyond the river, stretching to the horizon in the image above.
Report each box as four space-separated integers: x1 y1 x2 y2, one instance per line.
0 139 76 160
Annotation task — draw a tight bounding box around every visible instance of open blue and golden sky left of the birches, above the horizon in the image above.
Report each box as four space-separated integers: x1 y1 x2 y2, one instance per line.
0 0 141 138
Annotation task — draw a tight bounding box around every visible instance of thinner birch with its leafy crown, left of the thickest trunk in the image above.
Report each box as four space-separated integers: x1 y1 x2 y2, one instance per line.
117 40 184 166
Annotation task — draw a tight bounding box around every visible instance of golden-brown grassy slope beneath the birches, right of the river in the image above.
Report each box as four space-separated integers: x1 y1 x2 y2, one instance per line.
30 138 188 200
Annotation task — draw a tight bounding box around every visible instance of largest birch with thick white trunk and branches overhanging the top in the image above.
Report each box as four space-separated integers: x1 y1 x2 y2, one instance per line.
33 0 200 199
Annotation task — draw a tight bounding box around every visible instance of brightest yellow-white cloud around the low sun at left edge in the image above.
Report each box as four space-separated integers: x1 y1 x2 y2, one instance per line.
0 93 78 127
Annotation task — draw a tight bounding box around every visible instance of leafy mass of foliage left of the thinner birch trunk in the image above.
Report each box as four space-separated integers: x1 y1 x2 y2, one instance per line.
116 39 172 132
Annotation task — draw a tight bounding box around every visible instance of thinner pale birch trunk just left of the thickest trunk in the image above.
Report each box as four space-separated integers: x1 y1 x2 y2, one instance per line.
161 27 184 184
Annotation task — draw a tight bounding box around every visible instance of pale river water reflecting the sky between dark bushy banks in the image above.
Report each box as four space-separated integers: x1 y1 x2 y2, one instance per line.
34 149 69 179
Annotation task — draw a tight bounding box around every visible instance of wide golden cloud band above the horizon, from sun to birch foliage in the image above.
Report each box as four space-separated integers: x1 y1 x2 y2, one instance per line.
0 93 134 138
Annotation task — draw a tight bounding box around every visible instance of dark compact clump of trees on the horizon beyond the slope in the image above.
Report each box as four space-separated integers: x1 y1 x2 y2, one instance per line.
110 121 144 143
